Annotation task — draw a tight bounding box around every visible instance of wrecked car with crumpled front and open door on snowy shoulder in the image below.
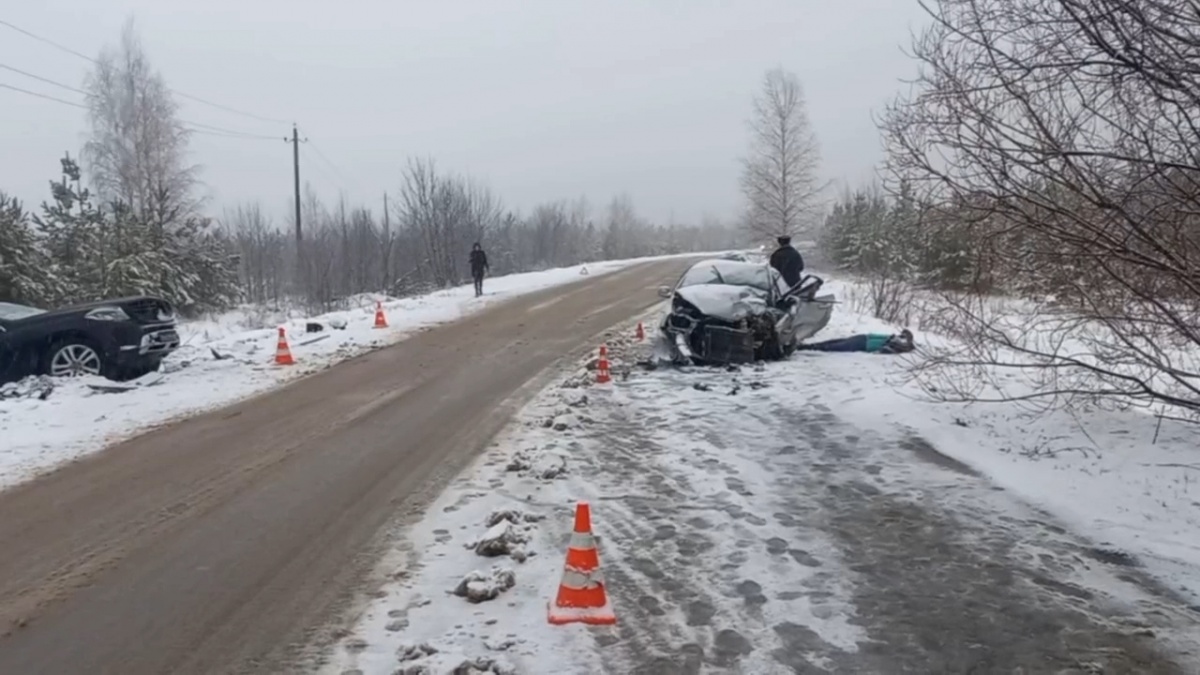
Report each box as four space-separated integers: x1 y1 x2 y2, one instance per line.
659 259 835 365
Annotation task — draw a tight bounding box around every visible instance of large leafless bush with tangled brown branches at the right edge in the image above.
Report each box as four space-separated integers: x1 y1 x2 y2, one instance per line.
882 0 1200 416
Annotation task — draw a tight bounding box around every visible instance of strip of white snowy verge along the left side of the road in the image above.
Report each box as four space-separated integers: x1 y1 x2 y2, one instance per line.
0 253 710 489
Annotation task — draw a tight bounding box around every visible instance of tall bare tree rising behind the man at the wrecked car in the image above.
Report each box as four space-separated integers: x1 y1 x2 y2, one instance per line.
742 68 824 237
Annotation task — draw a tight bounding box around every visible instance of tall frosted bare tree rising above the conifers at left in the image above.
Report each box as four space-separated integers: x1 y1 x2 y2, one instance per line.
84 19 199 228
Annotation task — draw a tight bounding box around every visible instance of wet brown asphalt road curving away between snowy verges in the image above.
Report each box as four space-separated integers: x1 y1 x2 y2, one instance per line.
0 261 688 675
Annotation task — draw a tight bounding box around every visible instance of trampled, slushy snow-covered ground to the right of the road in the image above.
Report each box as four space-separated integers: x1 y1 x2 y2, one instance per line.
326 275 1200 675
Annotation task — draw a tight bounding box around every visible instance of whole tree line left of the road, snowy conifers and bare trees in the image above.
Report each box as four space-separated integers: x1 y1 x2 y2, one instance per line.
0 23 745 313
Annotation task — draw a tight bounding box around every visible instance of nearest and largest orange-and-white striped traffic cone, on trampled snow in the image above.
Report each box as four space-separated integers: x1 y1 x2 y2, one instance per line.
548 502 617 626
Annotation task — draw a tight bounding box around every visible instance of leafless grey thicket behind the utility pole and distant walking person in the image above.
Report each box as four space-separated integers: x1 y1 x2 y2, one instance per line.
214 160 740 319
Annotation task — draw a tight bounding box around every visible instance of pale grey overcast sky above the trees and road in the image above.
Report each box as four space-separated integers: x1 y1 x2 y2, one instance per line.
0 0 922 221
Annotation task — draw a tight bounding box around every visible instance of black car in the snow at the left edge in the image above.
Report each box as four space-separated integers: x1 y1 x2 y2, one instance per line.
0 297 179 383
